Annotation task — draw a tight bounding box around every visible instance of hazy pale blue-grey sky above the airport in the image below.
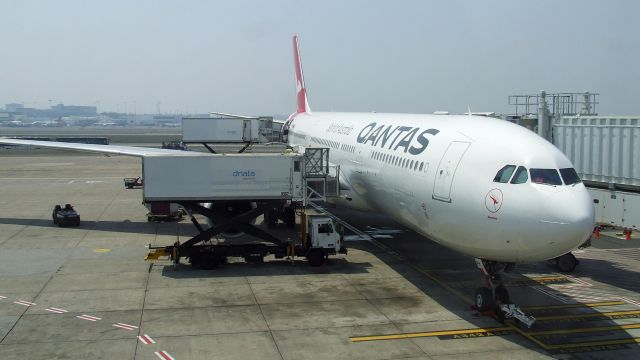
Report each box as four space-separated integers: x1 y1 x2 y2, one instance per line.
0 0 640 115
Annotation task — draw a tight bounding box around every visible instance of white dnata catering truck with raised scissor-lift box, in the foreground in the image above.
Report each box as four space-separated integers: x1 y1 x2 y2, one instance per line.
143 148 346 267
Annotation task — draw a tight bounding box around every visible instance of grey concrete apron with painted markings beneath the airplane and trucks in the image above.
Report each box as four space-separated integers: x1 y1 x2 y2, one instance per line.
0 149 640 360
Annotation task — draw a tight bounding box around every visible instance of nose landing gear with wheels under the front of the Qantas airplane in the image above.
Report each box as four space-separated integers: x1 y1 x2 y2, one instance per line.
475 259 536 327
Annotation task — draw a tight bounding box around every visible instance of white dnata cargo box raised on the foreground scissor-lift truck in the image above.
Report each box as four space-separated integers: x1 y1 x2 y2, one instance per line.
142 153 304 202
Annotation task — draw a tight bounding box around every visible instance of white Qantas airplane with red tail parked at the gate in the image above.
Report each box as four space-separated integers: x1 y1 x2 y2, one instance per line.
0 36 594 325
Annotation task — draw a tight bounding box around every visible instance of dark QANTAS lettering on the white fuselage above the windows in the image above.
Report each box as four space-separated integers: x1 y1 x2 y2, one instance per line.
357 122 440 155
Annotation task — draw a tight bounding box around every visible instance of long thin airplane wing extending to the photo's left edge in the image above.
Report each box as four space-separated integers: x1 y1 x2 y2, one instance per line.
0 137 206 157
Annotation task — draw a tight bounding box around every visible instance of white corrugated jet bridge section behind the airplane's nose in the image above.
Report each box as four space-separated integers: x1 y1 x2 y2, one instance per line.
553 116 640 186
